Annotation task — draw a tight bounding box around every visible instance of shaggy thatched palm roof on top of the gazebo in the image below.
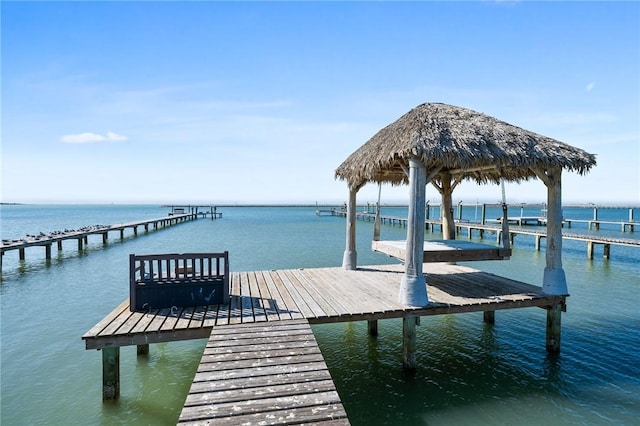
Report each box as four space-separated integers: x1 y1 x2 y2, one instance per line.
335 103 596 186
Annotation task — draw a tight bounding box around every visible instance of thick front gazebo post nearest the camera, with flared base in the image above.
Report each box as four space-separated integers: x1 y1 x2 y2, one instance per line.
398 158 429 306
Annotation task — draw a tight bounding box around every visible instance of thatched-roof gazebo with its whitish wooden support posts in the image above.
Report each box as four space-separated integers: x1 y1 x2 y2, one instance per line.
335 103 596 306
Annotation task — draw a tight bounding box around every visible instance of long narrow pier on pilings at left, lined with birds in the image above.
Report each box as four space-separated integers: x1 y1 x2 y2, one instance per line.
0 213 197 279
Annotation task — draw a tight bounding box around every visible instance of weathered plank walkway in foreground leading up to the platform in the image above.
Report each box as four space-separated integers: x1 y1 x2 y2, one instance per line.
178 320 349 425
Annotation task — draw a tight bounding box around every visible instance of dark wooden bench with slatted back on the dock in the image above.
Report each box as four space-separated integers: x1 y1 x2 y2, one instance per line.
129 251 229 312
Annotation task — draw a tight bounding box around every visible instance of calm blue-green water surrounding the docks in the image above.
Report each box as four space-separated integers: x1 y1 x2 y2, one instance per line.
0 206 640 425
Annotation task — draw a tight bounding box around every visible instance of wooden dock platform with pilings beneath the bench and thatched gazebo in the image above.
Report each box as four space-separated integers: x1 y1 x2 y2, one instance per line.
82 263 567 412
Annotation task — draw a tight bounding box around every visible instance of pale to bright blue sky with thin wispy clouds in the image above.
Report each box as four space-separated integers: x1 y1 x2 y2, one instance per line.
0 1 640 204
